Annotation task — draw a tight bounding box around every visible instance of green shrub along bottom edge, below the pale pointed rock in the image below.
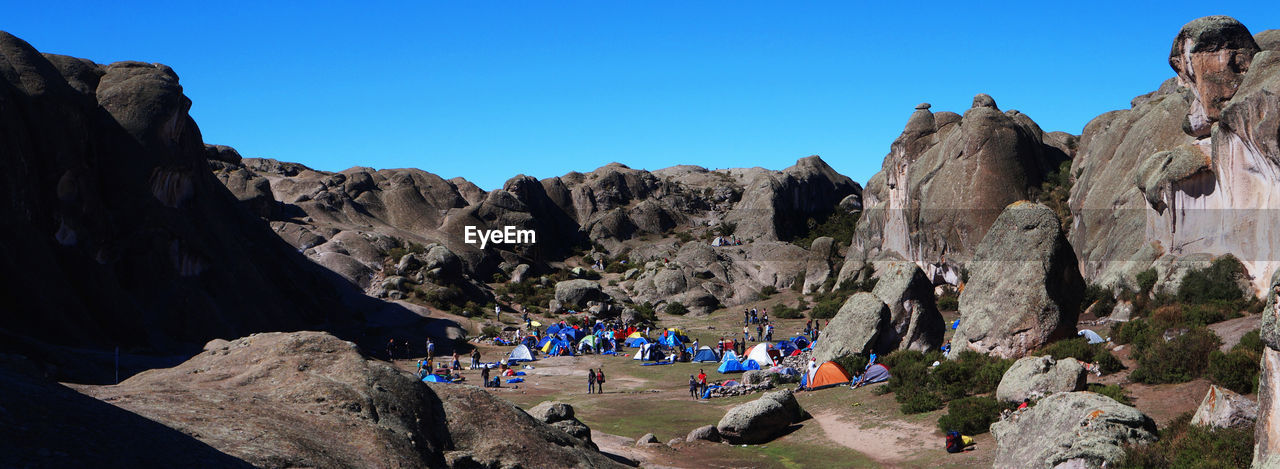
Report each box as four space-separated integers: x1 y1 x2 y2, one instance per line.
1115 413 1253 469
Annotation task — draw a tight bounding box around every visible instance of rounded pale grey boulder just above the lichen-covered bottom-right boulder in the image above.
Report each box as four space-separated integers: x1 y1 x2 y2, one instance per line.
996 355 1089 402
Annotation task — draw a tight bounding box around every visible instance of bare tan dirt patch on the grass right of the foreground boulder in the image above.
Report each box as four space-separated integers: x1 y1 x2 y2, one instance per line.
813 413 938 466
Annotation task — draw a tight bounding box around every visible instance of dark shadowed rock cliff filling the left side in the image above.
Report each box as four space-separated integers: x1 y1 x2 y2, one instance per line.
0 32 378 351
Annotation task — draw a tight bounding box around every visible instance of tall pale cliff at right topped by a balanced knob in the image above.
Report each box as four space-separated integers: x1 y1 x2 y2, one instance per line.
1070 17 1280 292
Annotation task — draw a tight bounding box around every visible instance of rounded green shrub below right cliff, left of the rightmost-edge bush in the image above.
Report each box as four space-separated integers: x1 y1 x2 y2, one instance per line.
1130 328 1222 384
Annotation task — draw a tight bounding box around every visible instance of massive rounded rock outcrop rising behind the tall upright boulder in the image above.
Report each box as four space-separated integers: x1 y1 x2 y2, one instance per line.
840 95 1069 284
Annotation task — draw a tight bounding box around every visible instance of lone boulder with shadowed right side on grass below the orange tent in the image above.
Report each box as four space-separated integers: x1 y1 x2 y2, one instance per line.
716 390 804 445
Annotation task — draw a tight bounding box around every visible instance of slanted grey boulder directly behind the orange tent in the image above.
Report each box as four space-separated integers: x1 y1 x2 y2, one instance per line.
813 292 897 363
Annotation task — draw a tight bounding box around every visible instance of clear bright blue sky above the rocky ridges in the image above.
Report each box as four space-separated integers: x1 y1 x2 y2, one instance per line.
10 0 1280 190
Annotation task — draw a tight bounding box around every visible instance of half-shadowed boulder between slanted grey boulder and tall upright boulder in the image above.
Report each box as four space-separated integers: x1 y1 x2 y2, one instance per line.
872 261 947 351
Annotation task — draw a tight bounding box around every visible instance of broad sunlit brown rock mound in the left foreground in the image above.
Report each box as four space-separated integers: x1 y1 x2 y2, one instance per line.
79 332 457 466
